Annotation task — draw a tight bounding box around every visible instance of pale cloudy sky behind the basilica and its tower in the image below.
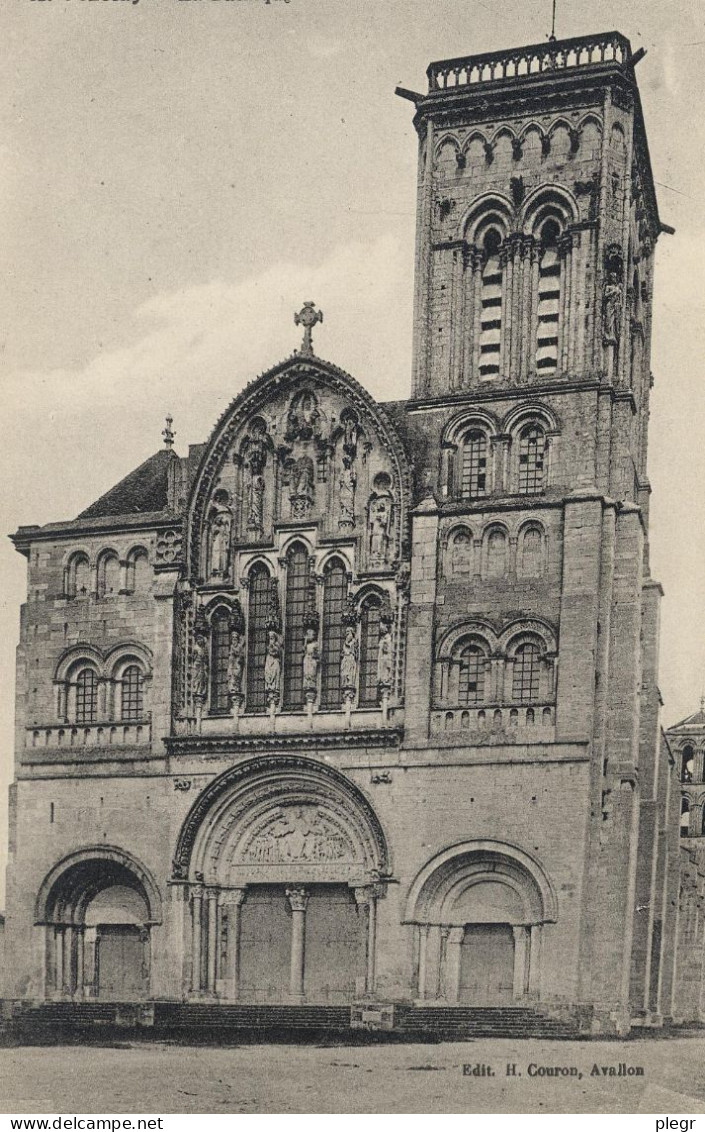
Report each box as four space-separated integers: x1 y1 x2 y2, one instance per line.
0 0 705 899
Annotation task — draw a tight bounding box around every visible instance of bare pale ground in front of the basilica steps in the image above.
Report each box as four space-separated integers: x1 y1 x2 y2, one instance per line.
0 1036 705 1114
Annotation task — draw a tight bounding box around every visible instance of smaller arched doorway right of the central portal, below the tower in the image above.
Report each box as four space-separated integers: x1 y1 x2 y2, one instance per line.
406 841 557 1006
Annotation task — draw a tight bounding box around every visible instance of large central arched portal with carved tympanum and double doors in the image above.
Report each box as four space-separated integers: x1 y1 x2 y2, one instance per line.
174 756 388 1003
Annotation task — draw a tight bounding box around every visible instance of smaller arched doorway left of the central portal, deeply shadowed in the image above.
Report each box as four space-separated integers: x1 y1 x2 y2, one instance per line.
36 847 162 1002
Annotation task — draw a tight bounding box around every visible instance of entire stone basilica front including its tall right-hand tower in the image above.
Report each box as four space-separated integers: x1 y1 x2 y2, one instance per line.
6 33 680 1031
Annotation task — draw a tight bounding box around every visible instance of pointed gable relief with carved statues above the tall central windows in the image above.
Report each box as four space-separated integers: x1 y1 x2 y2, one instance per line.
195 380 399 566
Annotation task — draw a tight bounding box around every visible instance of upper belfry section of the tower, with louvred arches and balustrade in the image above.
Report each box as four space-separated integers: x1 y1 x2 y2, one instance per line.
397 33 660 486
